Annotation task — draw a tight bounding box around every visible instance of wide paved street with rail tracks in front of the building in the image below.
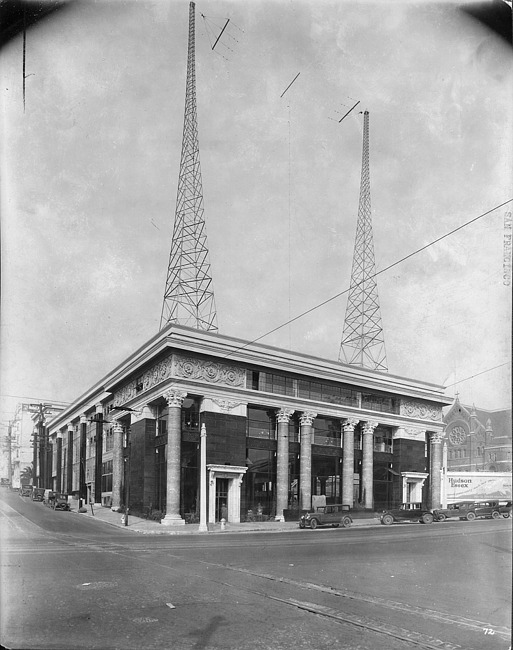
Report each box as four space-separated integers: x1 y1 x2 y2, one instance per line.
0 491 511 650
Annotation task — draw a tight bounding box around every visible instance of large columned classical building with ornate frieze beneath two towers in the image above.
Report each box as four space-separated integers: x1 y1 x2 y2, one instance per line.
49 325 449 525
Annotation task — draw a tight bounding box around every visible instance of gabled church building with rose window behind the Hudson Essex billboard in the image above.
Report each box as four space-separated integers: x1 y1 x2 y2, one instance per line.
444 397 511 472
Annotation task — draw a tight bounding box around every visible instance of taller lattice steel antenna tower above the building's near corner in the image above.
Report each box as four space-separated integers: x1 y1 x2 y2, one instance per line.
160 2 217 331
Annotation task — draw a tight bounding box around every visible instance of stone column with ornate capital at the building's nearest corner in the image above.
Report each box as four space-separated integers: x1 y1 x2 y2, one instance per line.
161 388 187 526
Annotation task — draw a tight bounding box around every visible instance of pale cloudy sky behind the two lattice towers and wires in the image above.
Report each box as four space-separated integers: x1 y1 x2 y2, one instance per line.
0 0 513 421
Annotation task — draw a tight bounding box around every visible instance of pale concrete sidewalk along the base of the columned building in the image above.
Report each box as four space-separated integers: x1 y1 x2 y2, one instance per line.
71 505 380 535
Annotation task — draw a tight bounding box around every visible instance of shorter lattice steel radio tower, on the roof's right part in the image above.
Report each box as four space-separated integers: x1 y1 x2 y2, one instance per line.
339 111 388 372
